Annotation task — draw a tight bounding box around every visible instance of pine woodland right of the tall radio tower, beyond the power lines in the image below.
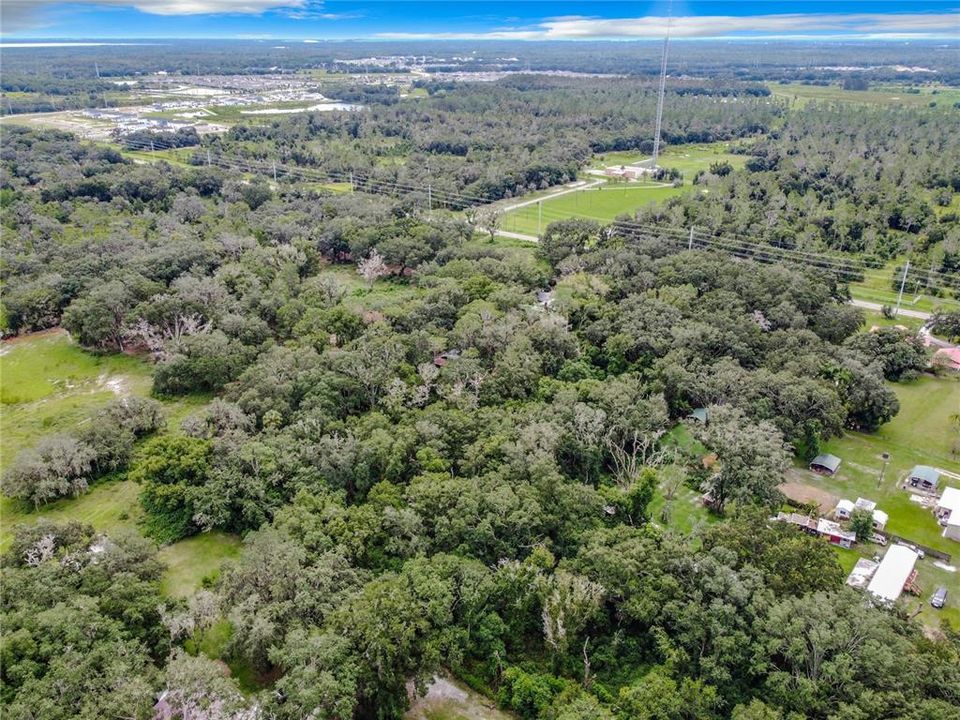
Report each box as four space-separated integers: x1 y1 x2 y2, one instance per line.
636 106 960 272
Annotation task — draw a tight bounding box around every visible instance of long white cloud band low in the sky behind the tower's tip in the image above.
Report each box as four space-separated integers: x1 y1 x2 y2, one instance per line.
377 12 960 40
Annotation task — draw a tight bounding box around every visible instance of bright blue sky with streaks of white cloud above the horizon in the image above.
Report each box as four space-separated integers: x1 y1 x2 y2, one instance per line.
0 0 960 40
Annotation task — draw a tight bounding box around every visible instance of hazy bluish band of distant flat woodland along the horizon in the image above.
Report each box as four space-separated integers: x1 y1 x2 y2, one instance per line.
2 39 960 84
